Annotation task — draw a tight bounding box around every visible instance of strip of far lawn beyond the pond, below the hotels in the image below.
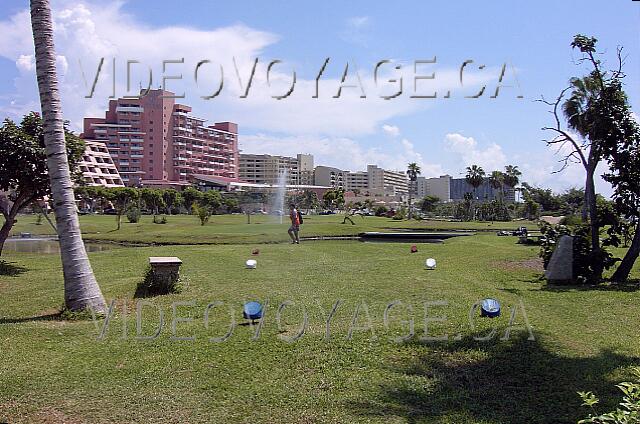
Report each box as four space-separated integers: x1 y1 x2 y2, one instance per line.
7 215 537 244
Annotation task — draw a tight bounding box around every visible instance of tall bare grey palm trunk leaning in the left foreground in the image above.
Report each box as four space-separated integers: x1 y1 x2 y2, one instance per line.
31 0 105 312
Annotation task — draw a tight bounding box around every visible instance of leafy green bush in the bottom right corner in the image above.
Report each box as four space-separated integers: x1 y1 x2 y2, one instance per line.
578 367 640 424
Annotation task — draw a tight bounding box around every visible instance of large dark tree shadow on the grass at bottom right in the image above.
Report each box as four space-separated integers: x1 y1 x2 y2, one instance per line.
350 336 640 424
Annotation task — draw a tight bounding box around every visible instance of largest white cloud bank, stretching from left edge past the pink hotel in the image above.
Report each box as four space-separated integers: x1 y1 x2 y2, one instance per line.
0 0 495 137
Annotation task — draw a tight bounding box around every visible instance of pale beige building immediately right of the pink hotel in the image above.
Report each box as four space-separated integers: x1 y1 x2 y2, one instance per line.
239 153 313 185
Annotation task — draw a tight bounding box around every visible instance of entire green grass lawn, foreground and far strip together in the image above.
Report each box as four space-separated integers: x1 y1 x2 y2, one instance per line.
0 217 640 424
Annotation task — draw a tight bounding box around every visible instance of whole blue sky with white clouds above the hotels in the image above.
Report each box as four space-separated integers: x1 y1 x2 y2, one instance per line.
0 0 640 194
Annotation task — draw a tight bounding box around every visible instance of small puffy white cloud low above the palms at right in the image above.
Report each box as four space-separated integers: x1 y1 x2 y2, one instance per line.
445 133 507 172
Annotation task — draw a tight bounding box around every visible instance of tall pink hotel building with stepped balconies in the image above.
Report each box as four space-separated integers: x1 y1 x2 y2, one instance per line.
81 90 239 186
